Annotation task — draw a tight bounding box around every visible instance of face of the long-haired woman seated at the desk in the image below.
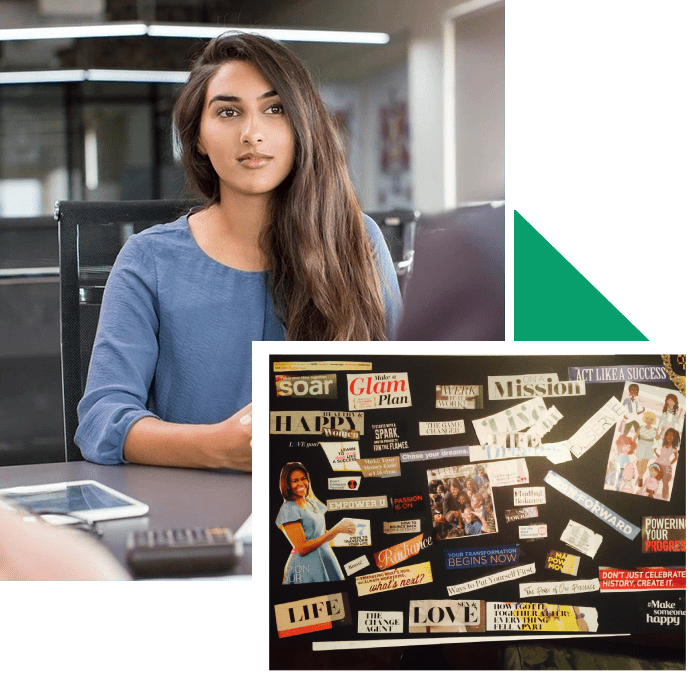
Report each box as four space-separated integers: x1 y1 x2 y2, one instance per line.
198 61 294 199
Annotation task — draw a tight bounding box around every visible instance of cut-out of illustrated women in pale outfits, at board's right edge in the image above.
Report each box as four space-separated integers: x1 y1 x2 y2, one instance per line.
604 382 686 500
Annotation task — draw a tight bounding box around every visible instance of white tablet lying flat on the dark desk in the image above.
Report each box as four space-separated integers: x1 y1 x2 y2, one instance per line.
0 481 148 525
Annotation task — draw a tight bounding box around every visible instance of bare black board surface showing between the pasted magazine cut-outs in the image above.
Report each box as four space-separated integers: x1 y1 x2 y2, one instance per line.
269 354 686 652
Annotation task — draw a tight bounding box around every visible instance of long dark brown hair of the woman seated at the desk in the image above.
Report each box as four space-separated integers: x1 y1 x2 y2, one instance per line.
174 33 386 341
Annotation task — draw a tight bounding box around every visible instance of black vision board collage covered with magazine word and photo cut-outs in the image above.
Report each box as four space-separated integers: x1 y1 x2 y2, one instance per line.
268 354 686 668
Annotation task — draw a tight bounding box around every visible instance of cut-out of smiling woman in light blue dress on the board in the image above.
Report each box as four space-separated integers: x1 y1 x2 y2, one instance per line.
276 462 356 585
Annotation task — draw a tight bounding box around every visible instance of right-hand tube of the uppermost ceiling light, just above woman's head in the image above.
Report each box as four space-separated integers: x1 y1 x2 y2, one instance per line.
148 24 390 45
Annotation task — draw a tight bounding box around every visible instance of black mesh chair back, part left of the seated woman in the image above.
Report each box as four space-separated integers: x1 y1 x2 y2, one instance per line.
55 201 187 462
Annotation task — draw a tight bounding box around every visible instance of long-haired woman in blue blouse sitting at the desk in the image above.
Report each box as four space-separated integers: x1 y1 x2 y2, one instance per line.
75 33 400 471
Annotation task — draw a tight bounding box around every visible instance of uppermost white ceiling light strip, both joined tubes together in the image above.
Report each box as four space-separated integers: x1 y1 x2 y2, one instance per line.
0 23 390 45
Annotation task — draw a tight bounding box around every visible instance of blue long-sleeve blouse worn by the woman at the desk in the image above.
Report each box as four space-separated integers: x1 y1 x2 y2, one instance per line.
75 216 401 464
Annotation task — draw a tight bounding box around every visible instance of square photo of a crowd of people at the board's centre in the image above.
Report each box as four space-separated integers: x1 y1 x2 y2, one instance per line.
427 464 498 540
